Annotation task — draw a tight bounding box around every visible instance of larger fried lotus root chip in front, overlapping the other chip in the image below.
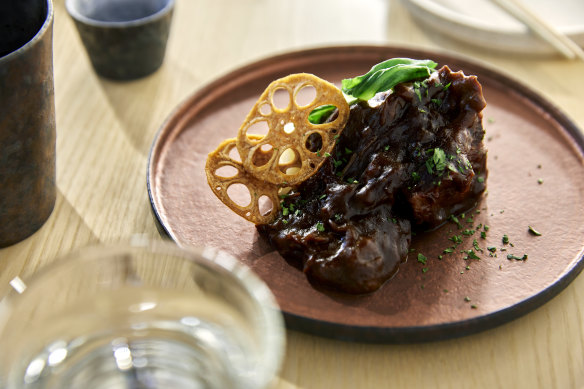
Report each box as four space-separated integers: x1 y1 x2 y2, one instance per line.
237 73 349 185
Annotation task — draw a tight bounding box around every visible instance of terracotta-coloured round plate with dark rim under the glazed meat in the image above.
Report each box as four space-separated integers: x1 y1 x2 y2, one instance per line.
148 46 584 342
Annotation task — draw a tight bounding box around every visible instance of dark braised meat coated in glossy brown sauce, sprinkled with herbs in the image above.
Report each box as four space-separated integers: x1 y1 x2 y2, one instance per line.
257 67 487 293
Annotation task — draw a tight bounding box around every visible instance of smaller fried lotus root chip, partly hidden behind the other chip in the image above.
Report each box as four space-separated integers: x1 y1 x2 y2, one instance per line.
205 137 279 224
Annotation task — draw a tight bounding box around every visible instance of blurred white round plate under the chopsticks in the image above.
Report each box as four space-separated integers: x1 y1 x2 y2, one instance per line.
404 0 584 54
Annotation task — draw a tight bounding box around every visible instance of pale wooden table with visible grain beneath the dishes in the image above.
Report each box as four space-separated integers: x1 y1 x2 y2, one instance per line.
0 0 584 388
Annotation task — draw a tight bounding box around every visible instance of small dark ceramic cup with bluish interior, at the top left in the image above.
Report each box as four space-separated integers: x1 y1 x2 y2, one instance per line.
65 0 174 80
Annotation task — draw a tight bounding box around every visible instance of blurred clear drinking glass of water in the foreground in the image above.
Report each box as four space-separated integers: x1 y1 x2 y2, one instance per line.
0 240 284 389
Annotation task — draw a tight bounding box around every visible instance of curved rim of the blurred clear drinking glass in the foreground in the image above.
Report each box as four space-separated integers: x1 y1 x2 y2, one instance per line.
0 236 286 388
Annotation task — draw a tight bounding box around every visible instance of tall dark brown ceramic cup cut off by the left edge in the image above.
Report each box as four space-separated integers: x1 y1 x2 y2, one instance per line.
0 0 56 247
